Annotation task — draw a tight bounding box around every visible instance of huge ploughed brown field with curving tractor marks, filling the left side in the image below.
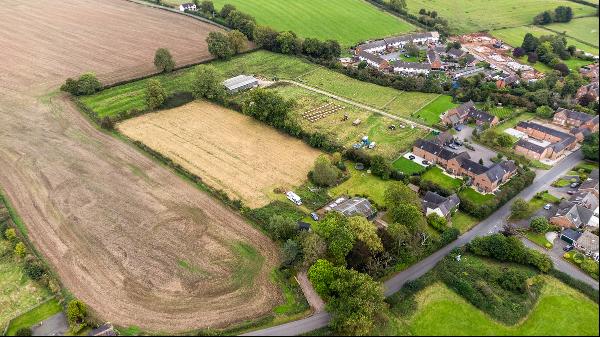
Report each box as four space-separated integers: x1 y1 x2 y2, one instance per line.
0 0 281 332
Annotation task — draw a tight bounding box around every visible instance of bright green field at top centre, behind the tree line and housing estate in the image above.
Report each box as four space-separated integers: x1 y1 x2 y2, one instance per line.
206 0 415 47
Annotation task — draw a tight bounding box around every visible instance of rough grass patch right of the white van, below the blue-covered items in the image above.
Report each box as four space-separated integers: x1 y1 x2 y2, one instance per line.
329 162 394 207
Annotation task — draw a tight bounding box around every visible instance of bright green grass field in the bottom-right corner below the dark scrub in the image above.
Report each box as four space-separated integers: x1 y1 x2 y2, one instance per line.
377 277 598 336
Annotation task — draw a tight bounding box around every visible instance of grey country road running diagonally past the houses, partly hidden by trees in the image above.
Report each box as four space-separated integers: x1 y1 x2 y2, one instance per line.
242 150 583 336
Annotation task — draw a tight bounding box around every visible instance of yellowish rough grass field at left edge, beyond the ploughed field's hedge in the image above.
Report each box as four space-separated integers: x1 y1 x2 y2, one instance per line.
0 240 50 329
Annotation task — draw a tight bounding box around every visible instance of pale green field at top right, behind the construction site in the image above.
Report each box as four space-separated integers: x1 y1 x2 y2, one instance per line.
406 0 596 34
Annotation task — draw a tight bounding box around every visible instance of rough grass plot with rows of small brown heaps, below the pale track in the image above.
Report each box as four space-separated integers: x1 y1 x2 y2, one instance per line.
269 84 427 161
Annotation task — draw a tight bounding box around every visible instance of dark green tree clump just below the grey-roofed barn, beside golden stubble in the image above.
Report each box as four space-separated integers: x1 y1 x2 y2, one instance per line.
242 88 294 128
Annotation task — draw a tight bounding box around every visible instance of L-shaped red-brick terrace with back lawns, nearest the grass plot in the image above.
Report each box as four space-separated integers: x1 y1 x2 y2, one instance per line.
413 139 517 193
